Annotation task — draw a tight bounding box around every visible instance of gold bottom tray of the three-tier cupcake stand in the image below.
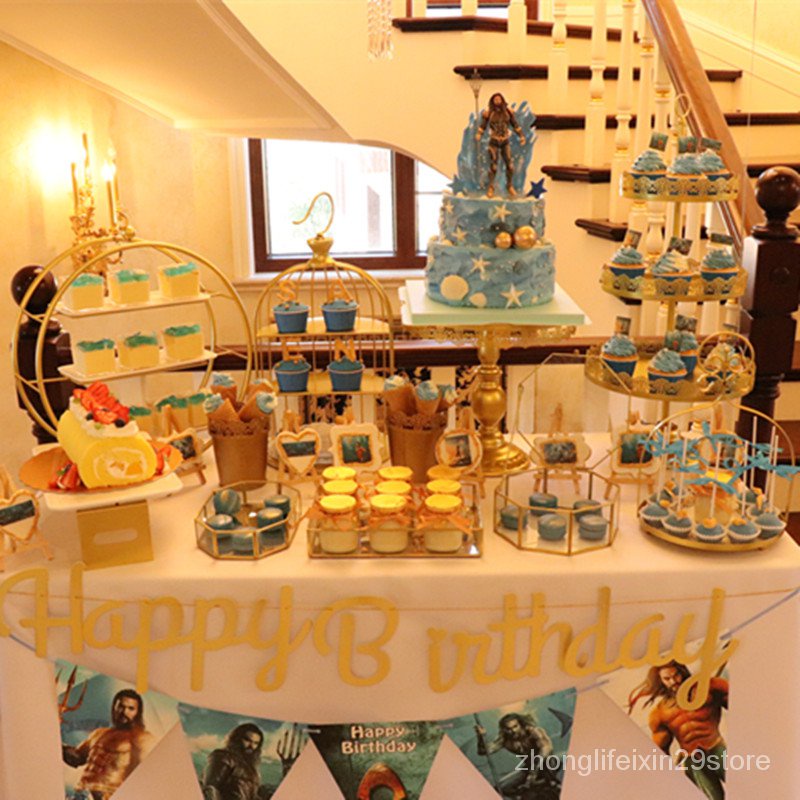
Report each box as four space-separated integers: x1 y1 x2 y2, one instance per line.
585 345 755 403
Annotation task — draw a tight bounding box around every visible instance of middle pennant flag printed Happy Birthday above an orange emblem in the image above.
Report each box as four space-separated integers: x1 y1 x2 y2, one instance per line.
309 722 442 800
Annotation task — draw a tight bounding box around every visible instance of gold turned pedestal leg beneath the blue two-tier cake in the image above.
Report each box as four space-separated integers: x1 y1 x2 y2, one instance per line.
472 328 530 477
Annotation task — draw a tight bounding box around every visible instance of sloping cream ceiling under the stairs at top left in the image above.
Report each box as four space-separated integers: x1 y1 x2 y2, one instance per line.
0 0 347 139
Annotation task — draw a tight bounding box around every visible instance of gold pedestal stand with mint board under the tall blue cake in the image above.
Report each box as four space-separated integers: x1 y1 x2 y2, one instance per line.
400 280 588 477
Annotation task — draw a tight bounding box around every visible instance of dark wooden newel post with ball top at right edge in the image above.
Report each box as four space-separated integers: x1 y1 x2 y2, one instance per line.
737 167 800 441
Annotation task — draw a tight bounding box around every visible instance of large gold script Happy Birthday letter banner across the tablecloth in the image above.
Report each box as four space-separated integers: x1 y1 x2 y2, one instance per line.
0 563 787 709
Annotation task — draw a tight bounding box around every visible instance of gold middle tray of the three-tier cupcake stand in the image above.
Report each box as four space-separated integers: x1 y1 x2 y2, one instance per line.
600 264 747 303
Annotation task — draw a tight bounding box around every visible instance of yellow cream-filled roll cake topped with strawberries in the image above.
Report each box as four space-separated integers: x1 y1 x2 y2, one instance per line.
57 383 157 489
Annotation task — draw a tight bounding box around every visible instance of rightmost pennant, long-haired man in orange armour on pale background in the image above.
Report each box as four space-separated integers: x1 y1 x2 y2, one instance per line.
602 640 728 800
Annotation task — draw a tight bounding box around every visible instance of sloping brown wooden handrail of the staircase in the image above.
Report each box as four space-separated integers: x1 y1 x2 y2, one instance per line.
642 0 763 252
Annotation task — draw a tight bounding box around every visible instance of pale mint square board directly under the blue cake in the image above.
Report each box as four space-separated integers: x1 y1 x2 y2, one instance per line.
398 280 590 327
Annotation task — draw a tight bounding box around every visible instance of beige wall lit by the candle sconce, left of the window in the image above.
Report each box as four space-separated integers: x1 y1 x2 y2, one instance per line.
0 44 233 469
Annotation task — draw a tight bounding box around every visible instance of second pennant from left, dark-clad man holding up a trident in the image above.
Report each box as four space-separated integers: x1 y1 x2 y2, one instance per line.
178 703 308 800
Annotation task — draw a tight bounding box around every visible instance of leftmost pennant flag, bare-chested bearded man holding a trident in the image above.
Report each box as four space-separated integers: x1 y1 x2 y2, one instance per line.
56 661 178 800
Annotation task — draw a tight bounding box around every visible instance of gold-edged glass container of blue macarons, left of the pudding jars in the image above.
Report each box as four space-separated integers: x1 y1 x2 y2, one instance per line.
194 481 302 561
